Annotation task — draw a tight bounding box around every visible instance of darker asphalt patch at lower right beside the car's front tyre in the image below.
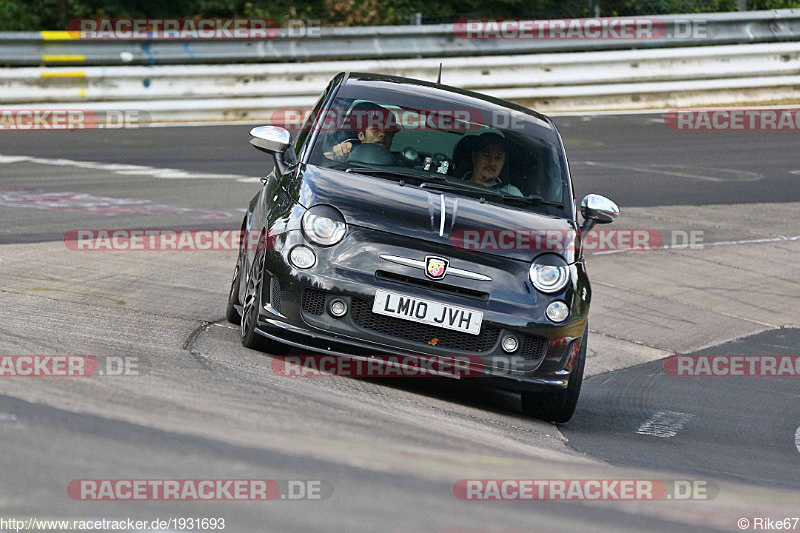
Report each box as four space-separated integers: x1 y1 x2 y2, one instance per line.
564 329 800 490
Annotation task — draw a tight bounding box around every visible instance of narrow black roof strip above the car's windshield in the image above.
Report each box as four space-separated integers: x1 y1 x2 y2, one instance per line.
344 72 555 129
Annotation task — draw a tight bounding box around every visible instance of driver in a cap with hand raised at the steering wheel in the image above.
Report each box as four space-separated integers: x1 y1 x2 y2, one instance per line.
325 102 400 161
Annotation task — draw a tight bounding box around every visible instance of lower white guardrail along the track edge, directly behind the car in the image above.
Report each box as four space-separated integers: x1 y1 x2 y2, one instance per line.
0 42 800 121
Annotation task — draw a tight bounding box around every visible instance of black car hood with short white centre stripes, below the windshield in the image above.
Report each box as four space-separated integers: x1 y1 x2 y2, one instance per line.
293 166 579 263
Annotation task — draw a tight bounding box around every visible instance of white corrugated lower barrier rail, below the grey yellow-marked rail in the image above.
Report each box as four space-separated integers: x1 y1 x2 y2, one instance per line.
0 42 800 104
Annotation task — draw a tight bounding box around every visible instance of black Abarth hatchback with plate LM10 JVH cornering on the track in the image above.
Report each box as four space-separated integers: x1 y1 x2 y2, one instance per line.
227 73 619 422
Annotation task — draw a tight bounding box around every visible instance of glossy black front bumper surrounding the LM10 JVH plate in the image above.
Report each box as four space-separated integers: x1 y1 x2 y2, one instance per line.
253 227 589 390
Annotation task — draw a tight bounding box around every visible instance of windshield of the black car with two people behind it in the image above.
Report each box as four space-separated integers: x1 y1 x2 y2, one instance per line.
309 82 569 208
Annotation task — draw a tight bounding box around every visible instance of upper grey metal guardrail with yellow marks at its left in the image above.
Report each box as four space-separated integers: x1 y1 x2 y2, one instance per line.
0 9 800 66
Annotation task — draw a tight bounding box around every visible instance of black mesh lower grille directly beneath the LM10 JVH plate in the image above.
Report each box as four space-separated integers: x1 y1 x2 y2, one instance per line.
352 298 500 352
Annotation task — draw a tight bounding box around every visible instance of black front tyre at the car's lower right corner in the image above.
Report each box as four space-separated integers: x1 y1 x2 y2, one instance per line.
521 325 589 424
